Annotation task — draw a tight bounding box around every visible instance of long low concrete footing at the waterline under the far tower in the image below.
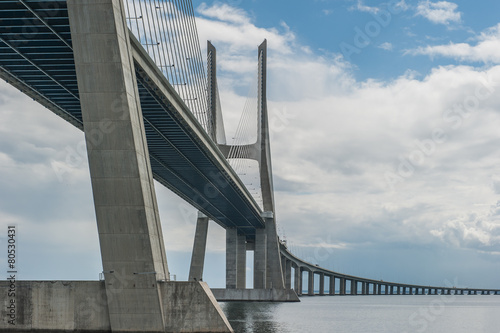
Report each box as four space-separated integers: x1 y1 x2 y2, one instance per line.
212 289 300 302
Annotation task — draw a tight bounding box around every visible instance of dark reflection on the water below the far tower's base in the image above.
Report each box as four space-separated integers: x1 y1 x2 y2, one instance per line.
221 302 286 333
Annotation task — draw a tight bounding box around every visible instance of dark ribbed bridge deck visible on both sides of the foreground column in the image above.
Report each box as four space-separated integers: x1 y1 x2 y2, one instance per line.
0 0 263 239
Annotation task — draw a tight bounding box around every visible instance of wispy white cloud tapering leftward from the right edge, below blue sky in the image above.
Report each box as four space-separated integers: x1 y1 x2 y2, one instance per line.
406 24 500 64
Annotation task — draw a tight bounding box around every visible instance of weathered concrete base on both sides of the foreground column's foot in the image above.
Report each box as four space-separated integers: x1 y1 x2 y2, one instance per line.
0 281 233 333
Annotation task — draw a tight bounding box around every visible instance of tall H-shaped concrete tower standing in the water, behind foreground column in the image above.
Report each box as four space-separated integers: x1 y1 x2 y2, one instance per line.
189 40 296 300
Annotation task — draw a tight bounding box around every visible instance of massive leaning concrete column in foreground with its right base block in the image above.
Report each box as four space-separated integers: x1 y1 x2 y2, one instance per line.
67 0 232 332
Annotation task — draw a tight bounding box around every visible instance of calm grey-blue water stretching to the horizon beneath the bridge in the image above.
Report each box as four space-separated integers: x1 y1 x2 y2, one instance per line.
221 295 500 333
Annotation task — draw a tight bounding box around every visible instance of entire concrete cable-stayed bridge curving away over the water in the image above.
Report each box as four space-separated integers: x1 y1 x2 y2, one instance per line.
0 0 500 332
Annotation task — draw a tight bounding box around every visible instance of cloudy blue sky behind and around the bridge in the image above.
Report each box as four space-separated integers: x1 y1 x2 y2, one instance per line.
0 0 500 288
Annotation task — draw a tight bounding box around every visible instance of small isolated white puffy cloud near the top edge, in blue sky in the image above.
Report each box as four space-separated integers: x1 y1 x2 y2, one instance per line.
417 0 462 25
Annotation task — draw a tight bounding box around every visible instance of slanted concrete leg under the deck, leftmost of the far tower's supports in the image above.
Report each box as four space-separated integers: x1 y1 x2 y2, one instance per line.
188 212 208 281
